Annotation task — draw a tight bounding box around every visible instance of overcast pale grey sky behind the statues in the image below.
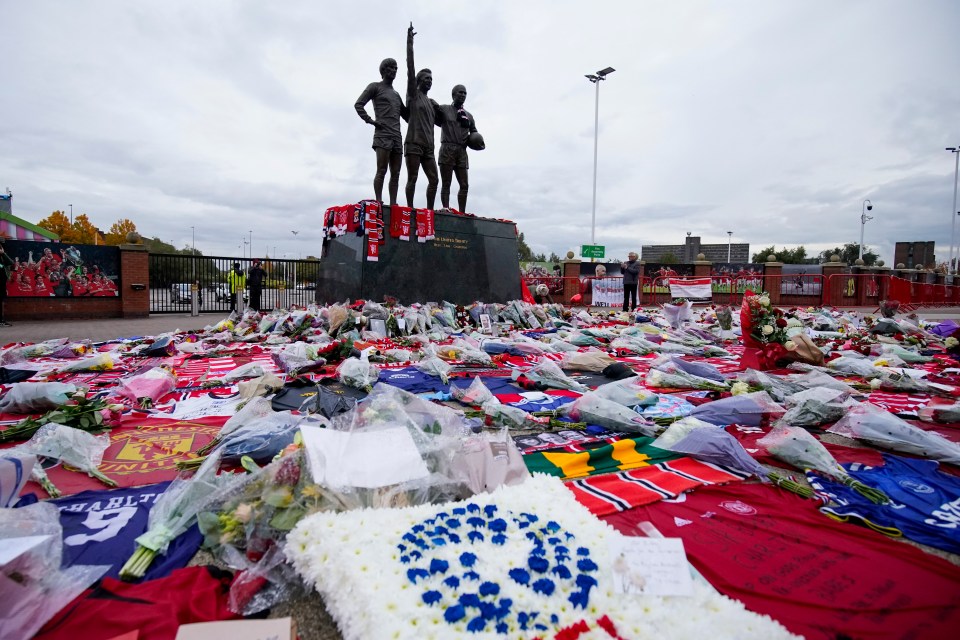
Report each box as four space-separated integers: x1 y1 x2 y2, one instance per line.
0 0 960 262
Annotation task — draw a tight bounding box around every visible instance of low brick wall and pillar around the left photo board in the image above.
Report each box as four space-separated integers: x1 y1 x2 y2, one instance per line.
5 245 150 320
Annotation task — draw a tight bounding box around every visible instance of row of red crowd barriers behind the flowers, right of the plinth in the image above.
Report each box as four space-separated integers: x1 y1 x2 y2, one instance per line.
524 273 960 310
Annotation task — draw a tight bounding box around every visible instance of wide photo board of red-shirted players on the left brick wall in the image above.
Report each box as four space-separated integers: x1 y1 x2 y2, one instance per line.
4 240 120 298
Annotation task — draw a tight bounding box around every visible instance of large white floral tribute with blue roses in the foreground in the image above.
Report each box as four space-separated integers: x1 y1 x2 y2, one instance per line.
286 475 795 640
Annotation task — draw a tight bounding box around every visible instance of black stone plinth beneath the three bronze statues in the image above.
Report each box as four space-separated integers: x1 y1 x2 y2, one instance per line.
317 207 520 304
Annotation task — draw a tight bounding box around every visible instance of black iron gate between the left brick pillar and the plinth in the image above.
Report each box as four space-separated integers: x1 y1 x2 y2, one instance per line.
150 253 319 315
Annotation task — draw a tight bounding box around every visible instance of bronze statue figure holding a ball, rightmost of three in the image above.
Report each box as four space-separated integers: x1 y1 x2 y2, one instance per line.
437 84 479 213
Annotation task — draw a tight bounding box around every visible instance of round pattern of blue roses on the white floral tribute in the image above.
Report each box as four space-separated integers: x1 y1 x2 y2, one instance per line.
397 502 598 634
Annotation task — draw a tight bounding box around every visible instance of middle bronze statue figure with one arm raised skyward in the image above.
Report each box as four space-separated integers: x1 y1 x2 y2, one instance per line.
403 22 440 209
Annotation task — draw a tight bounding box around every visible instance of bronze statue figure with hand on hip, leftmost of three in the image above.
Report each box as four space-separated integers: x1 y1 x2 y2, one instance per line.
354 58 407 206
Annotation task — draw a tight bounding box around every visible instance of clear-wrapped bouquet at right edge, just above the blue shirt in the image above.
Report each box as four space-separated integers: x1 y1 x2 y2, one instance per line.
827 402 960 466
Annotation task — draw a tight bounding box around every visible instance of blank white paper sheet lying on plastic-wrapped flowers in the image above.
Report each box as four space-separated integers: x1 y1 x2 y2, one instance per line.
301 427 430 489
